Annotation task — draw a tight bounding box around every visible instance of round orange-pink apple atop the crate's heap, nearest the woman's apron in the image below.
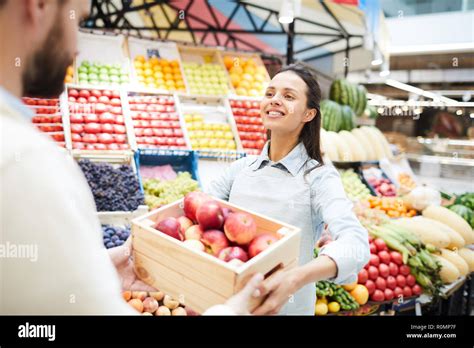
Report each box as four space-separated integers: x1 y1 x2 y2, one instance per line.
224 212 257 246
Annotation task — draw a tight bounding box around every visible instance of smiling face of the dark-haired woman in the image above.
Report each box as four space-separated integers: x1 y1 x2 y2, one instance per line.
260 71 315 134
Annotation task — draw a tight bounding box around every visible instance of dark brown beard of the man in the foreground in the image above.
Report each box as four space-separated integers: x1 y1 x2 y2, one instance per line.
22 16 72 98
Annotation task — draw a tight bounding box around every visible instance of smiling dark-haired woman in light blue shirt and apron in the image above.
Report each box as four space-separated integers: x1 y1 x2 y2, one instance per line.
209 64 369 315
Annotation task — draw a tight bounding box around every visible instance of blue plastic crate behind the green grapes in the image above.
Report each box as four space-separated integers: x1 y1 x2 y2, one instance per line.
135 149 201 190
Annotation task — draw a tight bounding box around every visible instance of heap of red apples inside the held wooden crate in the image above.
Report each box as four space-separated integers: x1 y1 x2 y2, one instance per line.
155 191 279 266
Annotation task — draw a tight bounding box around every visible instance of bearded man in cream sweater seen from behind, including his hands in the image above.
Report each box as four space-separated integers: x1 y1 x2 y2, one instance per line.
0 0 262 314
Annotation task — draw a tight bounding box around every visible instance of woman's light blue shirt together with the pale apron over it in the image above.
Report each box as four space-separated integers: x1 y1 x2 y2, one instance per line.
209 142 370 315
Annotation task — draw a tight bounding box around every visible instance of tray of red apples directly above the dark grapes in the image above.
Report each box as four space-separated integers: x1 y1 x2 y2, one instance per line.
68 89 130 150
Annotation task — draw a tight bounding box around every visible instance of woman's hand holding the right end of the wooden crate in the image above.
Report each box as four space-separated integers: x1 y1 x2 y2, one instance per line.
252 268 300 315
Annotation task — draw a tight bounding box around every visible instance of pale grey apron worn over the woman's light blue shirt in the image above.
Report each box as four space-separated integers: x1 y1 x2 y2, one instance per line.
229 165 322 315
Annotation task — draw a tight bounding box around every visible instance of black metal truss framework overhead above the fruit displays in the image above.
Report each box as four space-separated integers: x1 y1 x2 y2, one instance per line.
83 0 362 76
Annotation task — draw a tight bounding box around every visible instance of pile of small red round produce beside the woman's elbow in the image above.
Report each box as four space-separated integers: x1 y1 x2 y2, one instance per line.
357 236 422 302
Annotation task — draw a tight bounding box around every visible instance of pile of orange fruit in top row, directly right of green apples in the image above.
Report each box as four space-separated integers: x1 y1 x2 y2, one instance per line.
133 55 186 91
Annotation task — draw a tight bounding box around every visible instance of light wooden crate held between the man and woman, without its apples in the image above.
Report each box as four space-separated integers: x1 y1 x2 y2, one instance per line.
132 199 300 313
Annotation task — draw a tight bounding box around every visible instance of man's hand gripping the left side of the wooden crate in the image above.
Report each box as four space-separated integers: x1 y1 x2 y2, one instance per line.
108 237 157 291
